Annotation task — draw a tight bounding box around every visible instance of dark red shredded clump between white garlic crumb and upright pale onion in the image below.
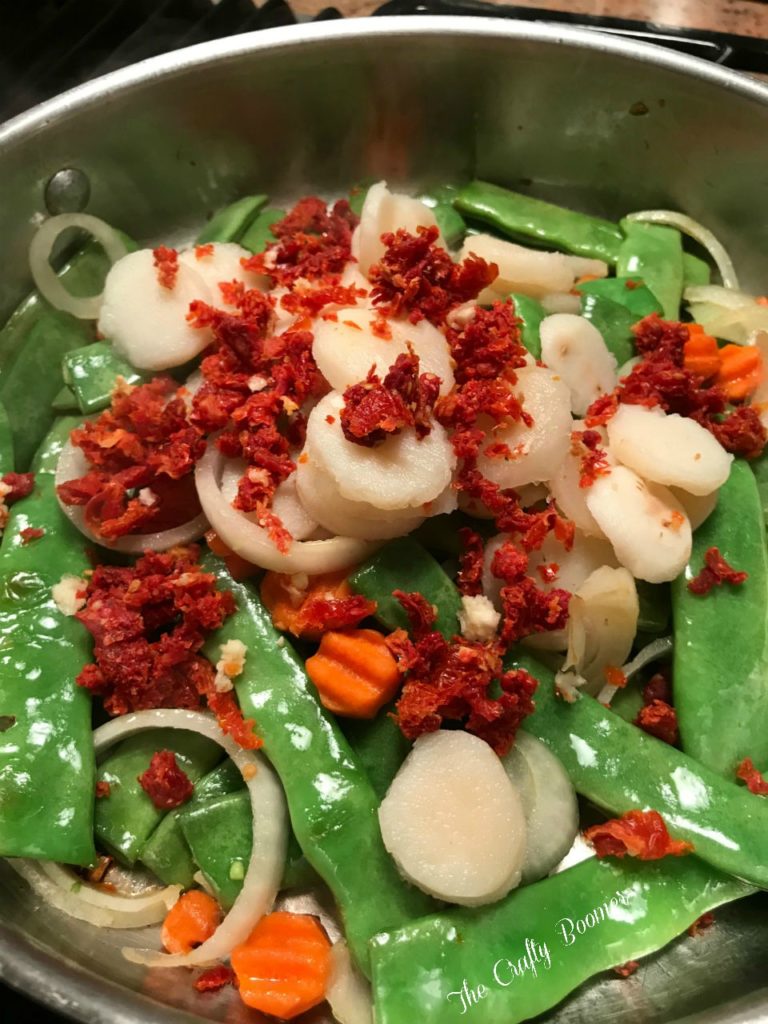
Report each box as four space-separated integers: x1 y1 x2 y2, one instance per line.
490 541 570 648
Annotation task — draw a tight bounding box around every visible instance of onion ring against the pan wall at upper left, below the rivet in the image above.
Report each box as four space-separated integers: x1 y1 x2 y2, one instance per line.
30 213 128 319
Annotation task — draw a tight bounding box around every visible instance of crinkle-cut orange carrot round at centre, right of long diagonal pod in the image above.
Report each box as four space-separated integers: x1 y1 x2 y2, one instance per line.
306 630 400 718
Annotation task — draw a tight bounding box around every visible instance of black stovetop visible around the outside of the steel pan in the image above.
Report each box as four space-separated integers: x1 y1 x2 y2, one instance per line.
0 0 768 1024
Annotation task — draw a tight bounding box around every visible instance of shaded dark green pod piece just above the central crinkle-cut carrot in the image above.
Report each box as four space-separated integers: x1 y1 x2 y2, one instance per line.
349 537 462 639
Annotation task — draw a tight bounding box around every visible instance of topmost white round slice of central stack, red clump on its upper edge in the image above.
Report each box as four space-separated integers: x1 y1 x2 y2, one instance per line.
306 391 456 515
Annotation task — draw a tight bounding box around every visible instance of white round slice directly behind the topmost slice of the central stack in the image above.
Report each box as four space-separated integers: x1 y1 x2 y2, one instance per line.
312 306 454 394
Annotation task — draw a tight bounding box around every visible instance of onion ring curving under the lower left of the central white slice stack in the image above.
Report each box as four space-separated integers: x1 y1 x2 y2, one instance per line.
195 442 376 575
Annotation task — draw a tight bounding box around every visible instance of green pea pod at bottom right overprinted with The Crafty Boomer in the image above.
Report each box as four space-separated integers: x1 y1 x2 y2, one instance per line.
371 857 751 1024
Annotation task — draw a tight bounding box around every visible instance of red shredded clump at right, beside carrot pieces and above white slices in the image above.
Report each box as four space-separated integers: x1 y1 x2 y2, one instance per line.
586 313 768 459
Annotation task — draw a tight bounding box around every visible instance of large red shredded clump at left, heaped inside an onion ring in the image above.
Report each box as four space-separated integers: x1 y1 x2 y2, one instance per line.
56 377 205 540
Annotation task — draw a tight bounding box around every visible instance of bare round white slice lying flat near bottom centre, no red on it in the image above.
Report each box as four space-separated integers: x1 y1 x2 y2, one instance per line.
379 731 526 906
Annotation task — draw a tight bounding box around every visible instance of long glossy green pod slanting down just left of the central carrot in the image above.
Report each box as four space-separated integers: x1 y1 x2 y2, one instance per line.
204 555 433 970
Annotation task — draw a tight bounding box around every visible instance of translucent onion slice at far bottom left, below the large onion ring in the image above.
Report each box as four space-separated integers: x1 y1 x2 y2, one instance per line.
8 859 181 928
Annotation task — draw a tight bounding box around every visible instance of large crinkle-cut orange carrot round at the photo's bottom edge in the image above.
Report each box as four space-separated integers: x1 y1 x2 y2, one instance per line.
230 910 331 1020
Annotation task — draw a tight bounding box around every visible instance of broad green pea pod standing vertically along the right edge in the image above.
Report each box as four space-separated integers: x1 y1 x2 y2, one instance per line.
672 459 768 779
